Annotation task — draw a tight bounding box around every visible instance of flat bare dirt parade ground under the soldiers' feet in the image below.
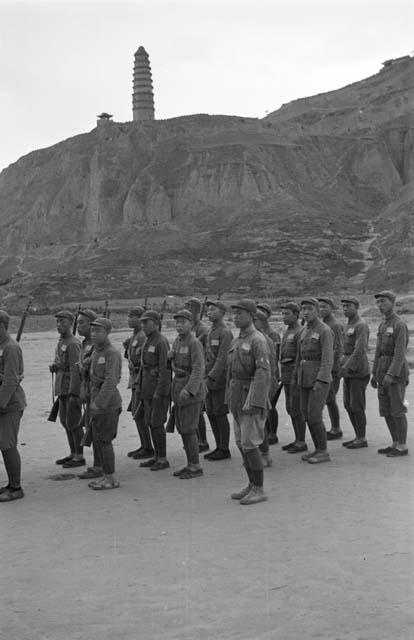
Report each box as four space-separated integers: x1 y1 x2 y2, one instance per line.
0 331 414 640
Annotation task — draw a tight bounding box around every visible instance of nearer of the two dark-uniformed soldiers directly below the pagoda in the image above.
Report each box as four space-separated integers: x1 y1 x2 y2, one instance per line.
138 310 171 471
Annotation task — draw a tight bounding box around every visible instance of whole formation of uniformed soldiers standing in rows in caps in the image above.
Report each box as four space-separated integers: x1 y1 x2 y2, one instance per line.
0 291 408 505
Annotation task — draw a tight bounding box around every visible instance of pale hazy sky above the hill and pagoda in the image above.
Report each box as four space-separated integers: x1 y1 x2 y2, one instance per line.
0 0 414 170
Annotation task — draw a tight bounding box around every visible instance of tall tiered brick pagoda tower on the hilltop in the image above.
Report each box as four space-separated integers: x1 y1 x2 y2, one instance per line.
132 47 154 121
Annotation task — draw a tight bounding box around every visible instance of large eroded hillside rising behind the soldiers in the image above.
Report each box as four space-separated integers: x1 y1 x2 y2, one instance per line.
0 60 414 302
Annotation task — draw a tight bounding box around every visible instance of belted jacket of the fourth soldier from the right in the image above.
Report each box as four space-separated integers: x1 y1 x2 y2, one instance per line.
295 319 333 388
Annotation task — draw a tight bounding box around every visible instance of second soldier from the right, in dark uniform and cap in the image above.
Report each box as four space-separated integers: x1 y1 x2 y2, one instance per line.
339 296 369 449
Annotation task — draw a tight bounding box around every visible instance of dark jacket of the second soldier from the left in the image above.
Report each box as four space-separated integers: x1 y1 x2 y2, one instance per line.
54 336 81 396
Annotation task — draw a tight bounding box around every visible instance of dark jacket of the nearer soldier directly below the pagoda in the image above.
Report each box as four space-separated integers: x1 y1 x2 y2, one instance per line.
138 331 171 400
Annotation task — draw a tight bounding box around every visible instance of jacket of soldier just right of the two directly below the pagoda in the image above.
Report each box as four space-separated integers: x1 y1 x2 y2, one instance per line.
171 333 206 405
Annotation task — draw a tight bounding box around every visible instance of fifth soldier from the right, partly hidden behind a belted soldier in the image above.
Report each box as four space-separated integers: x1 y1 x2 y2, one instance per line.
280 302 308 453
